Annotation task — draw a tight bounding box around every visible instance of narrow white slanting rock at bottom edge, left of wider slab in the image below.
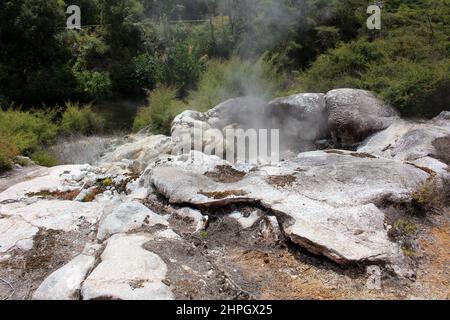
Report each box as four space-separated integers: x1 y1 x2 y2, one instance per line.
33 254 95 300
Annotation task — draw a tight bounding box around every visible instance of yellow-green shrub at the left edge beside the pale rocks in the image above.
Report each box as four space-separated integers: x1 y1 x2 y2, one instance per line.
0 108 58 154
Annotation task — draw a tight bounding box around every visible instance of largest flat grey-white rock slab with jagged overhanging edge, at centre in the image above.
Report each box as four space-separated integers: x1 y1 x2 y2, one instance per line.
147 151 429 263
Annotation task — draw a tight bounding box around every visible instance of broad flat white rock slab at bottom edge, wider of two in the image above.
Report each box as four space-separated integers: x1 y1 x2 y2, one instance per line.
81 234 173 300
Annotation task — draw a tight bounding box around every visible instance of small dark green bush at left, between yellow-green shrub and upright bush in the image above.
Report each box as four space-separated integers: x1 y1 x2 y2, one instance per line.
61 102 105 135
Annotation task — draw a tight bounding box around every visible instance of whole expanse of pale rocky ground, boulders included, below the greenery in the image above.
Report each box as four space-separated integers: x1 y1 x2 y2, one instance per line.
0 89 450 299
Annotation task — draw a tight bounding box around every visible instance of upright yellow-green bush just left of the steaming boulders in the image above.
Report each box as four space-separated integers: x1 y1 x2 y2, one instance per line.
133 87 185 135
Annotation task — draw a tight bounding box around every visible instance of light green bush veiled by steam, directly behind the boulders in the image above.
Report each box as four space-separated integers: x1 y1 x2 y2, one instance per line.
188 57 280 111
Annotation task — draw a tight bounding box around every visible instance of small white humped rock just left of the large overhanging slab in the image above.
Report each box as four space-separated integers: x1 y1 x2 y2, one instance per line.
97 202 168 240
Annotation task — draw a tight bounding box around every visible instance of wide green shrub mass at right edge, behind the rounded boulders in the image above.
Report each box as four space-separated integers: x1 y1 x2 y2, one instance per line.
292 21 450 118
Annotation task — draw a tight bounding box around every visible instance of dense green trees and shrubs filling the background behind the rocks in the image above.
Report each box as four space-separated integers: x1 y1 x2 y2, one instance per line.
0 0 450 117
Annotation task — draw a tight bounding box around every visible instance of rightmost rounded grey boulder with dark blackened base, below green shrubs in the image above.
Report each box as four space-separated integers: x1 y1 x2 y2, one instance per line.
325 89 398 146
